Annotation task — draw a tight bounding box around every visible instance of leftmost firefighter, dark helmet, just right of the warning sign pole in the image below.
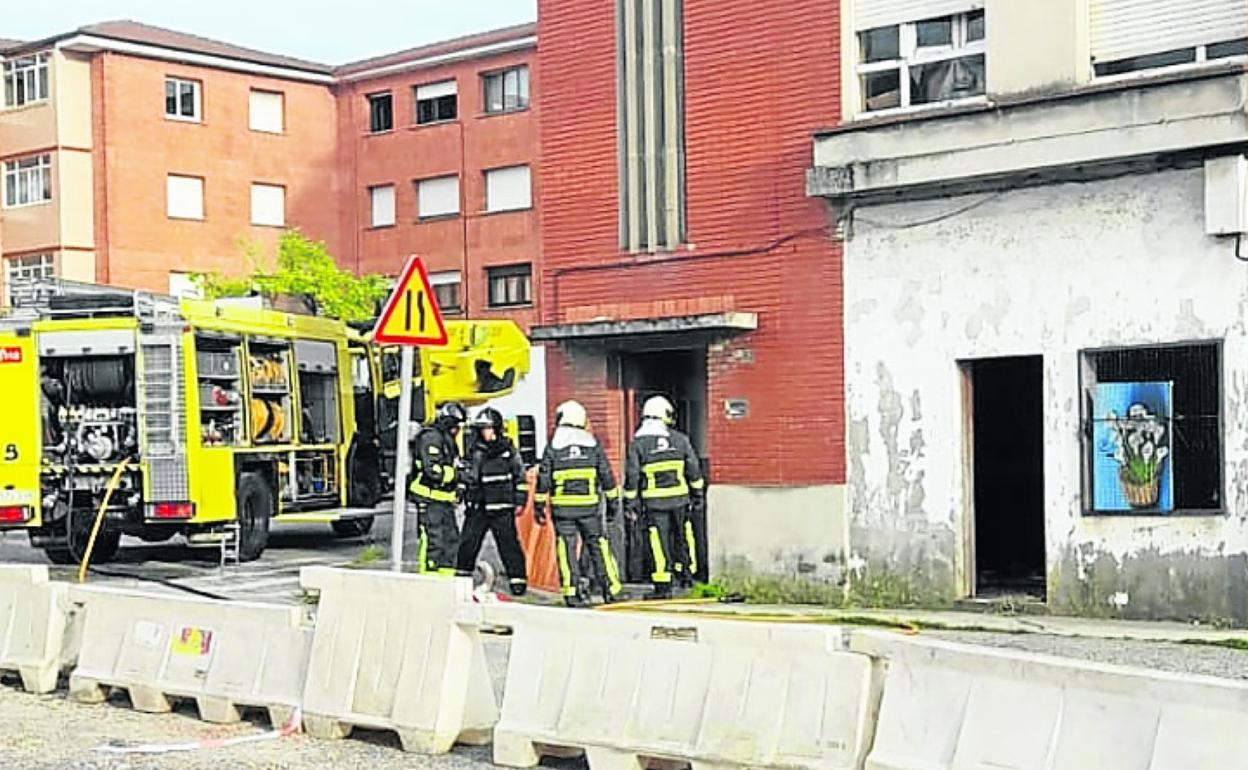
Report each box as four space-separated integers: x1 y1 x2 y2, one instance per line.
411 402 468 575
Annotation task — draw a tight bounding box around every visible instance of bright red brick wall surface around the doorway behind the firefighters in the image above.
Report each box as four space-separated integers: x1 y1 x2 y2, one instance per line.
538 0 845 484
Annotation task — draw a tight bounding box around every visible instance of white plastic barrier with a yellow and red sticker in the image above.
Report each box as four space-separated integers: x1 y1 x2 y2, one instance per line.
70 587 311 726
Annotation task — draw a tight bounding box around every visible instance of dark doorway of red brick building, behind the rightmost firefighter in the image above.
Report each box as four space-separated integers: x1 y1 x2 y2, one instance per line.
619 348 709 583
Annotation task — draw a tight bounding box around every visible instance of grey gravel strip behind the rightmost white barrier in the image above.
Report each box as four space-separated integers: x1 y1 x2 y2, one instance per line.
924 631 1248 679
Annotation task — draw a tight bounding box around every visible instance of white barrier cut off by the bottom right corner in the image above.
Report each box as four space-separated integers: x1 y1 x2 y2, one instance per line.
851 631 1248 770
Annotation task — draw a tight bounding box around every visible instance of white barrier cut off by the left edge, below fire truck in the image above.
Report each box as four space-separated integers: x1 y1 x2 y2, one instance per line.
0 564 70 693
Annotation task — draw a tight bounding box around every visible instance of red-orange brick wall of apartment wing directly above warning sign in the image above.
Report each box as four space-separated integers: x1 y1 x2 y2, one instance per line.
337 44 540 327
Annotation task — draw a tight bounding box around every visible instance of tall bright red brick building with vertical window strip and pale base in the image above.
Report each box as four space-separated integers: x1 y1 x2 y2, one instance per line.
534 0 846 575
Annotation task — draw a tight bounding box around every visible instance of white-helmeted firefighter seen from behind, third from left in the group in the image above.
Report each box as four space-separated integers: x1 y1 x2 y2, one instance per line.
533 401 623 607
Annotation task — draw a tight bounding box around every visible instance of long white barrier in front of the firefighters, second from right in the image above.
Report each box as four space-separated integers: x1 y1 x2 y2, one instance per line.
494 607 877 770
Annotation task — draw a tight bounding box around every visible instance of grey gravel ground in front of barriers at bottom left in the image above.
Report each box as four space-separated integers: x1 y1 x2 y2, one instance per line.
0 639 521 770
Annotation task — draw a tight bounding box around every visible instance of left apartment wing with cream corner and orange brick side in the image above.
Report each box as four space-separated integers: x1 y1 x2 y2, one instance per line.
0 22 338 300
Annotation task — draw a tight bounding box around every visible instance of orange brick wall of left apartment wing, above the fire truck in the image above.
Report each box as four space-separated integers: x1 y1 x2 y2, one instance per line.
92 52 341 291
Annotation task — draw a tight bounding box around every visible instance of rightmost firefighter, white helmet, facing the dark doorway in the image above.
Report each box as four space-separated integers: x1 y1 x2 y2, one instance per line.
624 396 706 599
